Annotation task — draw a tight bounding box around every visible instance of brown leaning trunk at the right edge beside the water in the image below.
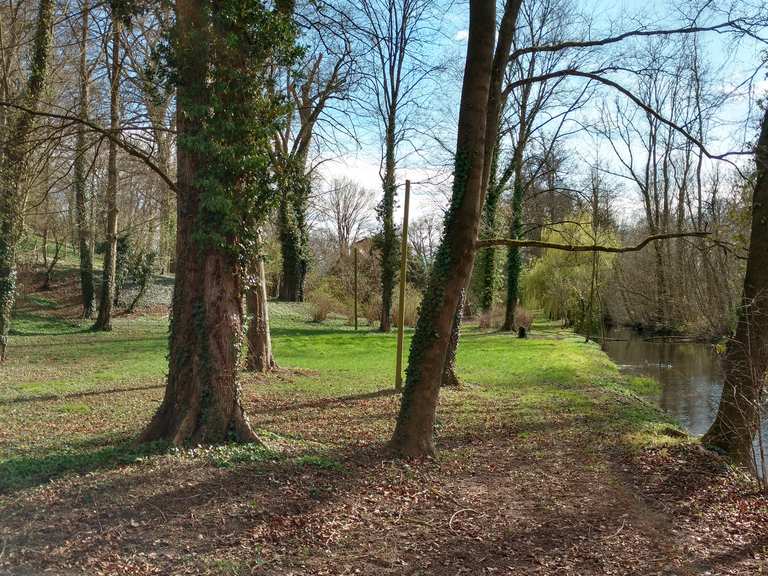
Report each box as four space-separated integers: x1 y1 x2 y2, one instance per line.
702 104 768 464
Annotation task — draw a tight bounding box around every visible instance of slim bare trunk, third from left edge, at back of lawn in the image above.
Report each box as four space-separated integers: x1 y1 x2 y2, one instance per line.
93 11 122 331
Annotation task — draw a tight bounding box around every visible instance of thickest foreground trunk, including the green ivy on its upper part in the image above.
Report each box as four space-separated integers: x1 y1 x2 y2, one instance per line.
142 0 295 444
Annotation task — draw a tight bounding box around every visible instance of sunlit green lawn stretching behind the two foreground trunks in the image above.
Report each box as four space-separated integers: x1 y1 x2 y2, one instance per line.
0 304 681 493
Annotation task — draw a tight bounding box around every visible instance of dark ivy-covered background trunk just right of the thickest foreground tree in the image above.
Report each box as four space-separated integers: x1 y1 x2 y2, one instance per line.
278 156 311 302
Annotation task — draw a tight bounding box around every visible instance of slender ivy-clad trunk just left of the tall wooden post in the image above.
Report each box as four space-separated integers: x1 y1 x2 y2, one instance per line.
377 117 399 332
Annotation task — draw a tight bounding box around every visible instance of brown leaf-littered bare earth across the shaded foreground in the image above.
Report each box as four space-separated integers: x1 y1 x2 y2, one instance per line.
0 380 768 576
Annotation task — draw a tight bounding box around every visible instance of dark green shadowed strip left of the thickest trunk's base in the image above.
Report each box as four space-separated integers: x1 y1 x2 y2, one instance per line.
0 436 168 495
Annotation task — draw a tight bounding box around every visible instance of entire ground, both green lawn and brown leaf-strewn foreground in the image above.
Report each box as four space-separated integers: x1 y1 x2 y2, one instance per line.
0 272 768 576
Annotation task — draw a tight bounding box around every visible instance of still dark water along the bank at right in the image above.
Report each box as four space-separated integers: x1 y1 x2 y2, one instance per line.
603 329 768 474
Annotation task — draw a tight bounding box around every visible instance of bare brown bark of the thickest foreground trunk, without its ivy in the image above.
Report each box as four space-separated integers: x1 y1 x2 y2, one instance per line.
141 0 258 445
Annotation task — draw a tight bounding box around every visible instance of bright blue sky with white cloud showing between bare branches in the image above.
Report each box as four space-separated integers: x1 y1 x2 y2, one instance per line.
320 0 768 230
